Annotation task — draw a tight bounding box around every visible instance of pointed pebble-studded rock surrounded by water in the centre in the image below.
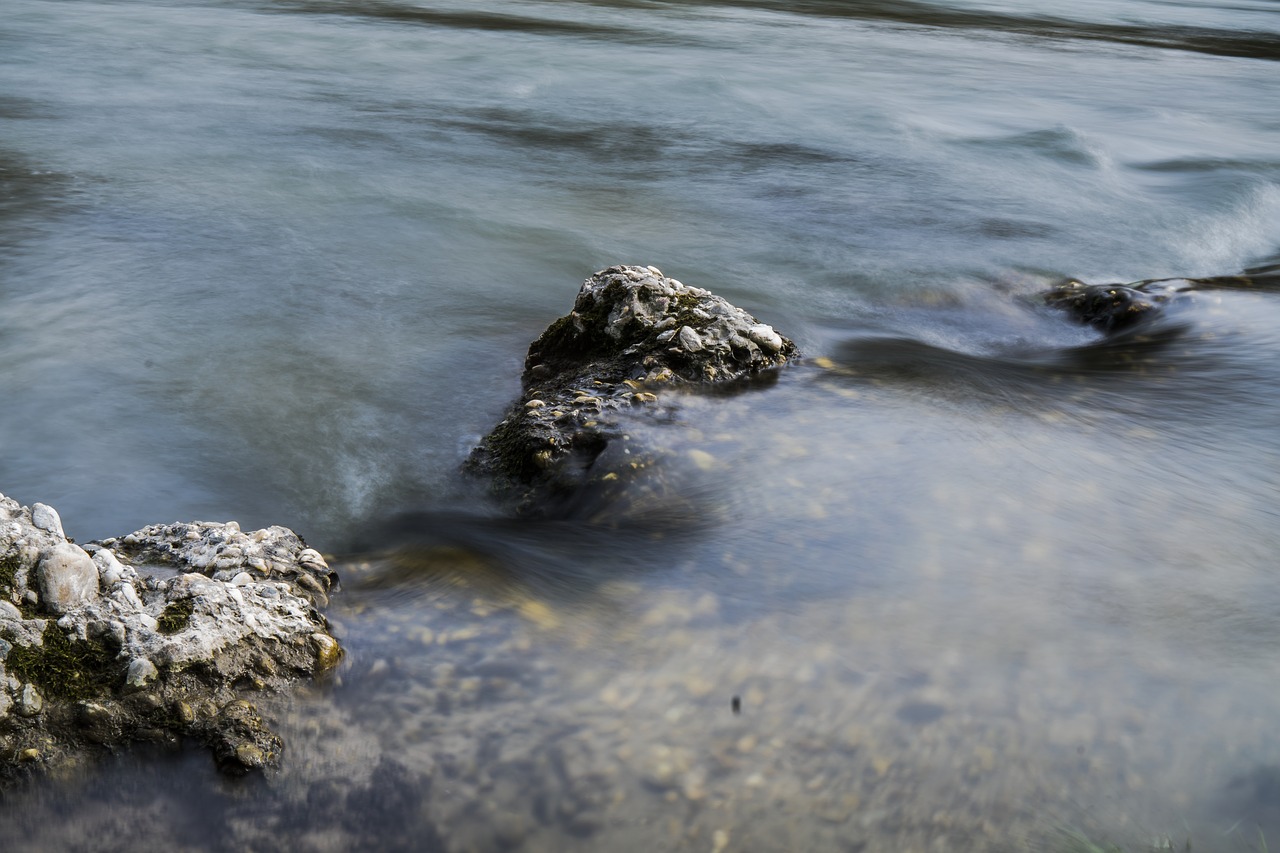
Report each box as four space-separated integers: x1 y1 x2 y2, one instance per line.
468 266 796 514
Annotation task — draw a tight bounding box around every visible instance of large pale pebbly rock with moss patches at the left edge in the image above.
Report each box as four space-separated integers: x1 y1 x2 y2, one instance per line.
0 494 340 776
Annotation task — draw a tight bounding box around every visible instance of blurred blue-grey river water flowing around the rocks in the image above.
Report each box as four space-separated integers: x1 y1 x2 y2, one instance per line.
0 0 1280 850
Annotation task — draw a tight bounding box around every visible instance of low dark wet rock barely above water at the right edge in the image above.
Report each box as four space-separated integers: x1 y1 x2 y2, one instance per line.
1043 265 1280 332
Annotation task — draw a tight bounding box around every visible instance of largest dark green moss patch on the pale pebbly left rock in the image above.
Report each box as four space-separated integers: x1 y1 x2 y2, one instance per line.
5 621 122 701
